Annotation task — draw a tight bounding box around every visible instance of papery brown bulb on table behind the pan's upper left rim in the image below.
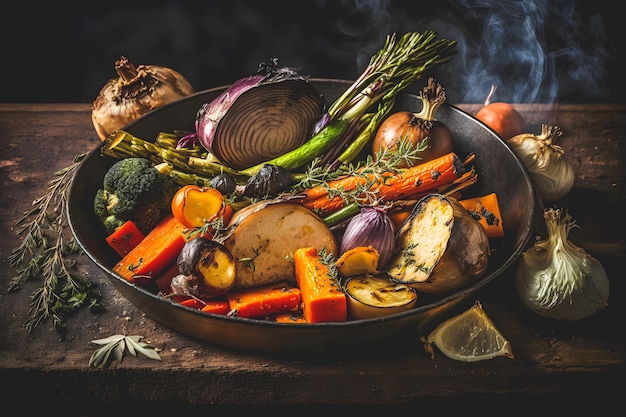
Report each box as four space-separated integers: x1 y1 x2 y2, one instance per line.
91 56 194 140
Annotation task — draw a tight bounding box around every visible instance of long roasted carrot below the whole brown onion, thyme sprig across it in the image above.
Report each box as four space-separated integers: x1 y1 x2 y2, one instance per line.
299 152 466 216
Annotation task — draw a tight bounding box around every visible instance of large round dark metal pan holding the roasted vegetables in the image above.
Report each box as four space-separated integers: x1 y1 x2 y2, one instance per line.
68 79 537 356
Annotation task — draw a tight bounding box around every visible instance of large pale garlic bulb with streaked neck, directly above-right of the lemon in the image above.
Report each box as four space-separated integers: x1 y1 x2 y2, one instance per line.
515 209 609 321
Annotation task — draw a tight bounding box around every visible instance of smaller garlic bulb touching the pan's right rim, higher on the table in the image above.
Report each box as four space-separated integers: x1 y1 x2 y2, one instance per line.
507 125 574 201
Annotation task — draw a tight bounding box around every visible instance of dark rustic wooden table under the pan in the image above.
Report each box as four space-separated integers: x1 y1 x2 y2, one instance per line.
0 104 626 416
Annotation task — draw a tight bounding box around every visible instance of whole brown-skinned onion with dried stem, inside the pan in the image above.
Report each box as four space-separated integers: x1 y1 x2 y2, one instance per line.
372 77 454 165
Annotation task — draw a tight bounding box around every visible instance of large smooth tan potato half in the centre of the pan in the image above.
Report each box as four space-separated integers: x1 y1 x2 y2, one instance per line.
223 200 338 288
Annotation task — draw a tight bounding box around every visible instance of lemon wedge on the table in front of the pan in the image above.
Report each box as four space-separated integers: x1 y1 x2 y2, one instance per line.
421 301 514 362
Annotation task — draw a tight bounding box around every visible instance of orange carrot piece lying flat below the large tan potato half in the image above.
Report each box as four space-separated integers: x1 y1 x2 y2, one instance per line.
226 283 302 317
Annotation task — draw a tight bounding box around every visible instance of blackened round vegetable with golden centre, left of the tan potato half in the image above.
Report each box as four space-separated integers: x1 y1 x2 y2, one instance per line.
171 236 236 299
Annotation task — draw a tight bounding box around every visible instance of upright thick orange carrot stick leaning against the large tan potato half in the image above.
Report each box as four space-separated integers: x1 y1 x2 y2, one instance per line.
293 247 348 323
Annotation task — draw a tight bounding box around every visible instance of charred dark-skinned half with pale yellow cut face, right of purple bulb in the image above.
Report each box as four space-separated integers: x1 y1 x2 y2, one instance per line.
387 194 489 294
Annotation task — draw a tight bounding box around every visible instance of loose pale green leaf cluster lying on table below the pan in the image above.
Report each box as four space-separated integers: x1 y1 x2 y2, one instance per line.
89 334 162 368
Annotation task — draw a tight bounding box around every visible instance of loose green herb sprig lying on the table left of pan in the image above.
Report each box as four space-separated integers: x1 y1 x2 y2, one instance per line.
7 154 100 333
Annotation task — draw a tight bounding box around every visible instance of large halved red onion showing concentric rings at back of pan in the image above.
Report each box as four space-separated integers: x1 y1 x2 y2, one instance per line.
196 68 324 170
